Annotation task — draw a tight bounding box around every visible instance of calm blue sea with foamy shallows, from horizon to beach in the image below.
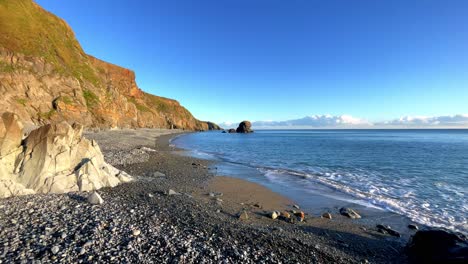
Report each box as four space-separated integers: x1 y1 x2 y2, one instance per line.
172 129 468 234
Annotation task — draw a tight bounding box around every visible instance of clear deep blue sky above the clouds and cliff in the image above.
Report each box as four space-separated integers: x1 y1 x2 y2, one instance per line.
36 0 468 125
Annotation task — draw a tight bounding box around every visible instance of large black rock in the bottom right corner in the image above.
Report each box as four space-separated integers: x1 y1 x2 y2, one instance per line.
407 229 468 263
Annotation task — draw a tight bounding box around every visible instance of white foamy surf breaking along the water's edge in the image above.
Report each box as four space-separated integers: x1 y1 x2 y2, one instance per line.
174 135 468 233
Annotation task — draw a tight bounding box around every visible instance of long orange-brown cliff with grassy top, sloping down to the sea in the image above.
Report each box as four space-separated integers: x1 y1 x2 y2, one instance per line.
0 0 219 130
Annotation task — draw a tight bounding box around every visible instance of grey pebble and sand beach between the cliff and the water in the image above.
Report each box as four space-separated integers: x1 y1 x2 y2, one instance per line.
0 130 464 263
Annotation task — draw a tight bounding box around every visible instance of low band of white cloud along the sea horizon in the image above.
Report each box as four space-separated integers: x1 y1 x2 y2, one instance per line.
220 114 468 129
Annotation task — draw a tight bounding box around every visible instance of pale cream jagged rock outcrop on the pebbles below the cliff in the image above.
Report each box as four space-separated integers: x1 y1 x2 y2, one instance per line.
0 113 131 197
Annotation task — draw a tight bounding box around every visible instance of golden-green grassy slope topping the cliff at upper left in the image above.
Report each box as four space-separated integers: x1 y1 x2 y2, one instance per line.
0 0 100 85
